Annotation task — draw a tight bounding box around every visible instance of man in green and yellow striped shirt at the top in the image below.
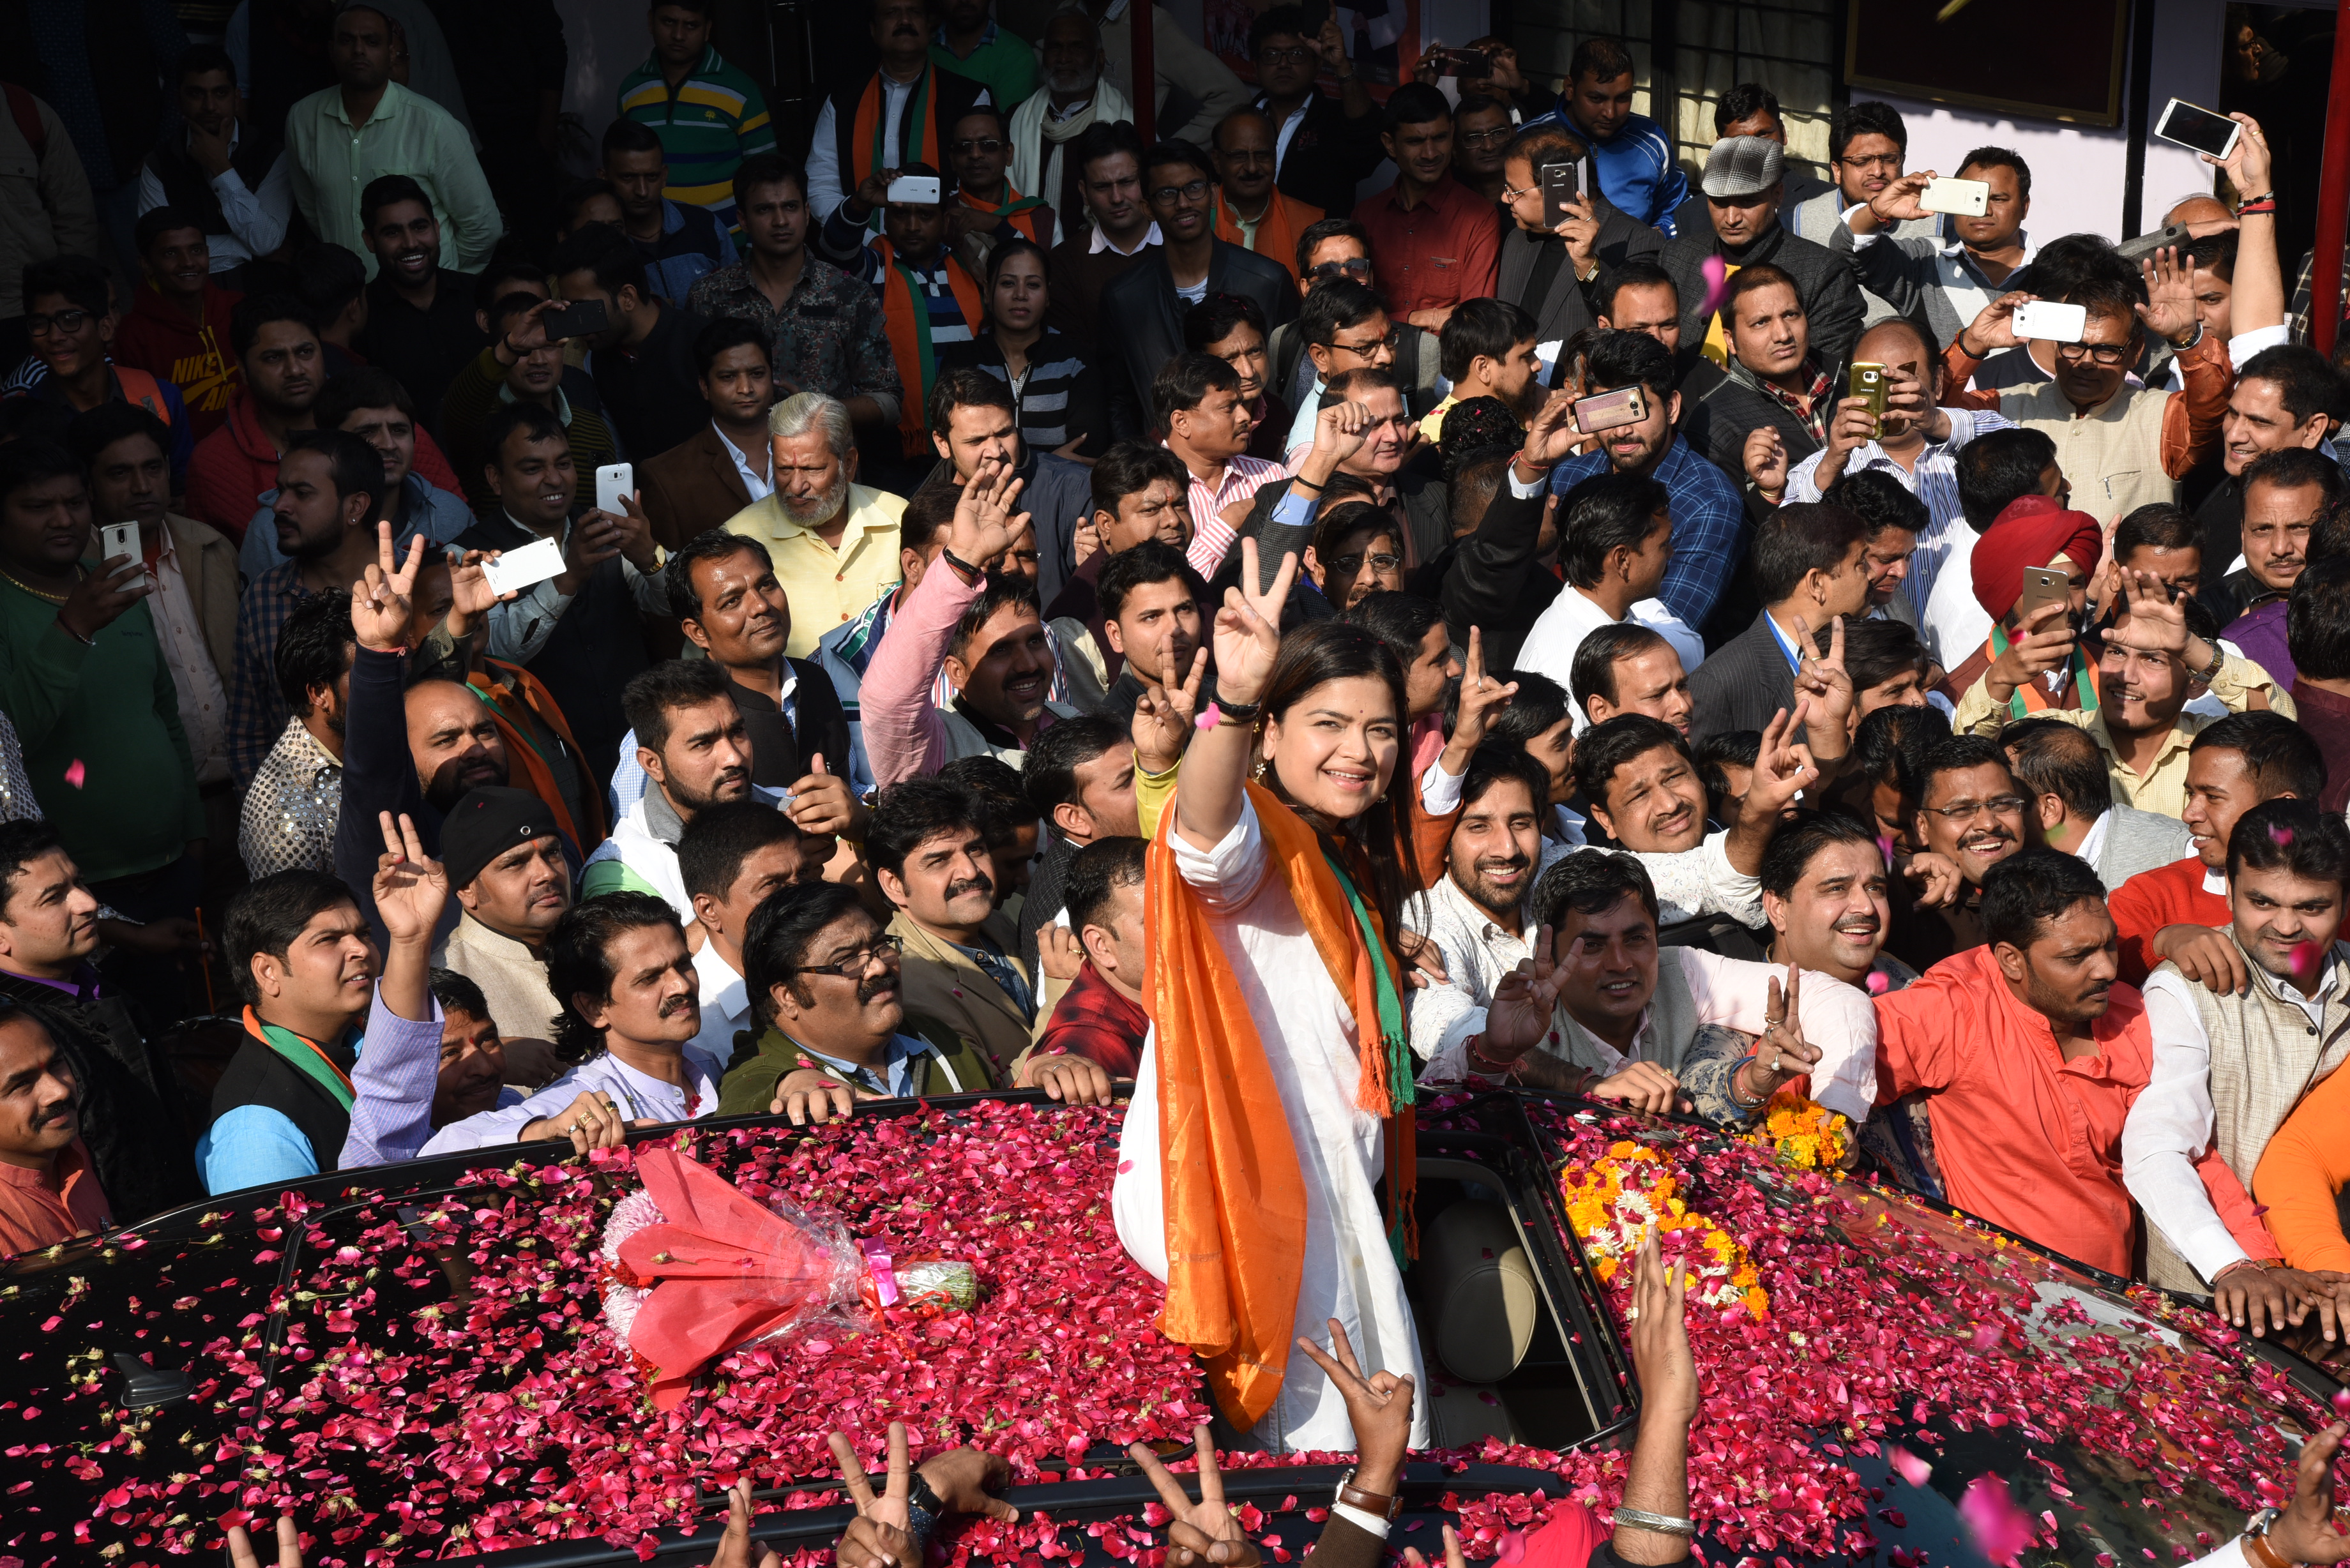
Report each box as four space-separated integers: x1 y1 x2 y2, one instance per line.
621 0 775 240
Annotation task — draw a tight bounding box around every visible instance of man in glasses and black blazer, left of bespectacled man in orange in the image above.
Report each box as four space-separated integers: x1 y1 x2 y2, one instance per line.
1095 141 1297 440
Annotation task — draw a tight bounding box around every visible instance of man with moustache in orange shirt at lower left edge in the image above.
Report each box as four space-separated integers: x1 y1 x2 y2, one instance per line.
0 1004 113 1258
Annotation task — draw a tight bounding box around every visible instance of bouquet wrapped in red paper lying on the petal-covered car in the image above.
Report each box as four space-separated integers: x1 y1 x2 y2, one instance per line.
602 1147 978 1410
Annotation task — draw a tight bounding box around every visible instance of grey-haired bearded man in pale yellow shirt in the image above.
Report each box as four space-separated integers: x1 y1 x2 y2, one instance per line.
726 393 905 658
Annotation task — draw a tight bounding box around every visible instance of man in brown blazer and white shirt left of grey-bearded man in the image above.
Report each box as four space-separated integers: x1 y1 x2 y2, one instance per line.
637 315 775 550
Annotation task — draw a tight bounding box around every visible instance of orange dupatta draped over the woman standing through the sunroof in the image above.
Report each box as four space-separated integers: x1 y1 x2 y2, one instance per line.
1144 778 1452 1431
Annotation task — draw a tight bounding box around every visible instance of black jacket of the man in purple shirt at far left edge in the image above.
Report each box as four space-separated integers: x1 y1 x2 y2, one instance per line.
0 973 204 1225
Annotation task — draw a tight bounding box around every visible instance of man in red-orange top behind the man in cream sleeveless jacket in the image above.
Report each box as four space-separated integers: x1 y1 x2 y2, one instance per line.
2111 712 2326 990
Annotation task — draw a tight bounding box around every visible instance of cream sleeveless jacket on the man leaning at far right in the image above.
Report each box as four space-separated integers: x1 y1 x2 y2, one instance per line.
2146 926 2350 1295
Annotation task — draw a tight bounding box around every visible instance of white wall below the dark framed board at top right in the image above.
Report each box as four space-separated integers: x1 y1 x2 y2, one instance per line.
1854 0 2225 240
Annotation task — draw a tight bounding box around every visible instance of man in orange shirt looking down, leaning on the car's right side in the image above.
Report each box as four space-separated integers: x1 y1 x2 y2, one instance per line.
1876 848 2277 1279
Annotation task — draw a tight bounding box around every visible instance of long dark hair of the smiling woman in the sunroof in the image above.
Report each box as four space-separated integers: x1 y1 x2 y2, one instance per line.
1259 621 1420 969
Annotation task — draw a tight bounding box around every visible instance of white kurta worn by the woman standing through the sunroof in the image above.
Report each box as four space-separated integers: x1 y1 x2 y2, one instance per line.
1112 802 1429 1451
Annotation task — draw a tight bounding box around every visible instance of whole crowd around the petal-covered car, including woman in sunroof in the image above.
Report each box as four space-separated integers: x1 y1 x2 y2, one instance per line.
0 0 2350 1564
